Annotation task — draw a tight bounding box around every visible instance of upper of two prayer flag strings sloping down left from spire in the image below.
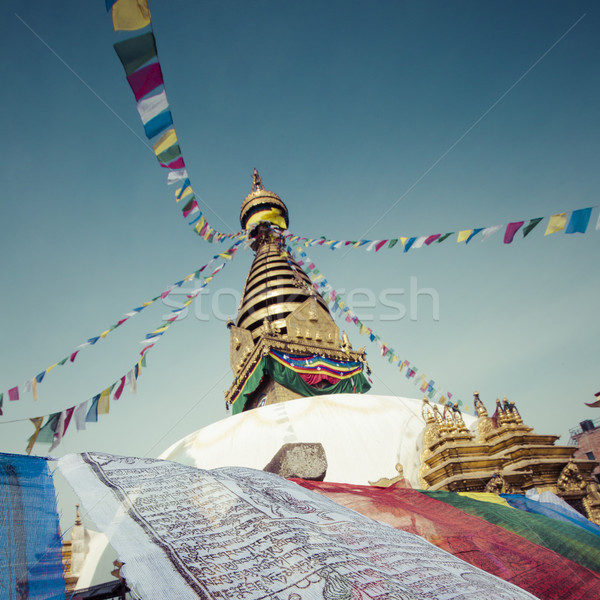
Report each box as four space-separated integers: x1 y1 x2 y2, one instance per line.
0 240 242 416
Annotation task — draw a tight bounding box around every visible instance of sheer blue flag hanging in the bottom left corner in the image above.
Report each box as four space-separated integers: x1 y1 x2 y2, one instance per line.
0 454 65 600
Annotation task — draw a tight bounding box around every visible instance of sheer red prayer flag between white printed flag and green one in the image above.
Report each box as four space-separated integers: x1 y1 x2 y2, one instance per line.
295 479 600 600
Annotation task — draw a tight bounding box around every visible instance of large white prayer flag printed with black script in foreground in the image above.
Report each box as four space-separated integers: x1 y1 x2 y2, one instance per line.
58 453 534 600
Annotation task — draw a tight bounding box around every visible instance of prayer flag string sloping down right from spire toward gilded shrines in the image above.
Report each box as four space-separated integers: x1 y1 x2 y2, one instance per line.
289 243 463 406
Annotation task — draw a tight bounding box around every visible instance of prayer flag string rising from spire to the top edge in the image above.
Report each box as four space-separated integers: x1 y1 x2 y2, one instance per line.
106 0 246 243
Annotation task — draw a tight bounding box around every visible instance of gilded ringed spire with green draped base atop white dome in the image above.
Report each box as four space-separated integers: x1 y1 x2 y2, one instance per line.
225 169 370 414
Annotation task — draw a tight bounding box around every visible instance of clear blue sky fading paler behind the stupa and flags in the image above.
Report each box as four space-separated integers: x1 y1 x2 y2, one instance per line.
0 0 600 467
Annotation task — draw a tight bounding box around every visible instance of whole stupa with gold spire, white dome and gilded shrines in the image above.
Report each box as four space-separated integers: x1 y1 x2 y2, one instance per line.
161 169 600 523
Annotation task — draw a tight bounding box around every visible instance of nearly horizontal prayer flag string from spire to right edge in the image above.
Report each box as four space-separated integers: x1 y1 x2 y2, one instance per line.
285 206 600 252
